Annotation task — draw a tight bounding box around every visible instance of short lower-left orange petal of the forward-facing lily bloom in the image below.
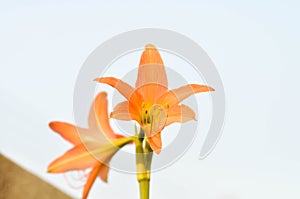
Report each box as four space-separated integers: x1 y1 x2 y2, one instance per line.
110 101 138 120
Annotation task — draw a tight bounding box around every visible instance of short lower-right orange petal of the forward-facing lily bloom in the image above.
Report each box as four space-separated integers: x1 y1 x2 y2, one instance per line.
166 105 195 126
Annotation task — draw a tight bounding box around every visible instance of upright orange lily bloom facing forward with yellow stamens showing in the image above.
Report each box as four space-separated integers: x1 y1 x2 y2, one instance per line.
95 44 214 153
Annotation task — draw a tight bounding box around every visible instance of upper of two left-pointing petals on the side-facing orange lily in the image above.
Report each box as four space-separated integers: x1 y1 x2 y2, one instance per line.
49 122 88 145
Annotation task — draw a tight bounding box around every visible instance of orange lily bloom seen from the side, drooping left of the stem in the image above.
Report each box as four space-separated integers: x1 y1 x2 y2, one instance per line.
48 92 134 198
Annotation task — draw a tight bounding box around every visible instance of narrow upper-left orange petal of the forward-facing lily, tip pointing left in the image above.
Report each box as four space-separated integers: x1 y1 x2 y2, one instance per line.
95 77 134 100
